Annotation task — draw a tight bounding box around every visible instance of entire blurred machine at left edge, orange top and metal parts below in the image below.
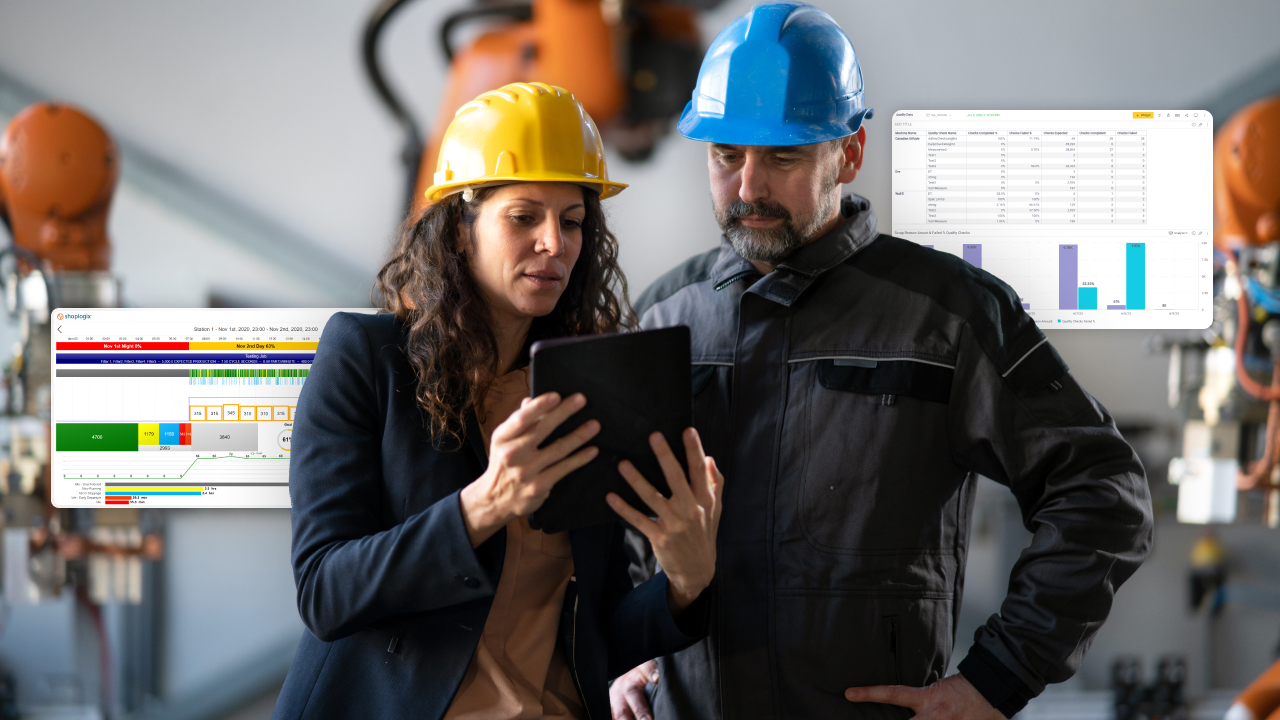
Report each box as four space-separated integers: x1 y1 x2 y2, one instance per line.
0 102 163 714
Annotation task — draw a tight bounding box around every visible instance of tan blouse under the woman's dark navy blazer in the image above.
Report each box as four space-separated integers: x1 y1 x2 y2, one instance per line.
444 369 586 720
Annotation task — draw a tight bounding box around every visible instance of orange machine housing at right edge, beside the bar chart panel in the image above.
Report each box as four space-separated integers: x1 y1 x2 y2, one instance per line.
1213 97 1280 251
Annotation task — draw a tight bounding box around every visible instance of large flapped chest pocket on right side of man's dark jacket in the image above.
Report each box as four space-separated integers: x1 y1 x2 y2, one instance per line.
796 360 965 555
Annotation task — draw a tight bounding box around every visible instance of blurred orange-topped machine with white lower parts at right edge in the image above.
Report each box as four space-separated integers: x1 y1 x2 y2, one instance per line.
1164 97 1280 528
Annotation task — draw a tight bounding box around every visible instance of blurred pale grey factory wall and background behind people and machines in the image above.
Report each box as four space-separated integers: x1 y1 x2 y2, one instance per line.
0 0 1280 719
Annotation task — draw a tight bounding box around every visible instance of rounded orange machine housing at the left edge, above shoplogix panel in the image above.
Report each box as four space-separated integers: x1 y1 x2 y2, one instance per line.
0 102 120 270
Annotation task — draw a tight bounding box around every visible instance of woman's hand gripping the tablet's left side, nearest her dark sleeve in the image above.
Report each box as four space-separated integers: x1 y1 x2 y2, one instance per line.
460 392 600 547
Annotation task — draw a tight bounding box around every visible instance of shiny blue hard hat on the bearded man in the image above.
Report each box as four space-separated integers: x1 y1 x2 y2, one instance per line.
676 3 872 145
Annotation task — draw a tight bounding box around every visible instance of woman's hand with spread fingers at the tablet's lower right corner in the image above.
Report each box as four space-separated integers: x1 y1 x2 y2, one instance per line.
605 428 724 615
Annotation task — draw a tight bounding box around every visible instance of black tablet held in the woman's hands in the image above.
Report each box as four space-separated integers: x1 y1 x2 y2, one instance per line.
529 325 694 533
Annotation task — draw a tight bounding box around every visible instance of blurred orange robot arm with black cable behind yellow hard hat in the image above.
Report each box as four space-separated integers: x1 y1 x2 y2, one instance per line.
362 0 723 211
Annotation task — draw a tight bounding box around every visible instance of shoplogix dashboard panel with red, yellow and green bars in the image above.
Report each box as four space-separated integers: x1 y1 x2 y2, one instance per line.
50 307 372 507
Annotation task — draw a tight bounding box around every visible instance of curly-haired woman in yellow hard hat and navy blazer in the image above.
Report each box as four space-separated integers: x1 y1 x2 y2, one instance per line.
274 83 723 720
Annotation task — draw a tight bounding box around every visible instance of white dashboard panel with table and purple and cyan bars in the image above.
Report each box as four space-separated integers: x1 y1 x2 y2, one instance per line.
892 110 1213 329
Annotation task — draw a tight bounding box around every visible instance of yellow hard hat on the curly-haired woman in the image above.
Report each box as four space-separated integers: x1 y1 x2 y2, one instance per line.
426 82 626 202
